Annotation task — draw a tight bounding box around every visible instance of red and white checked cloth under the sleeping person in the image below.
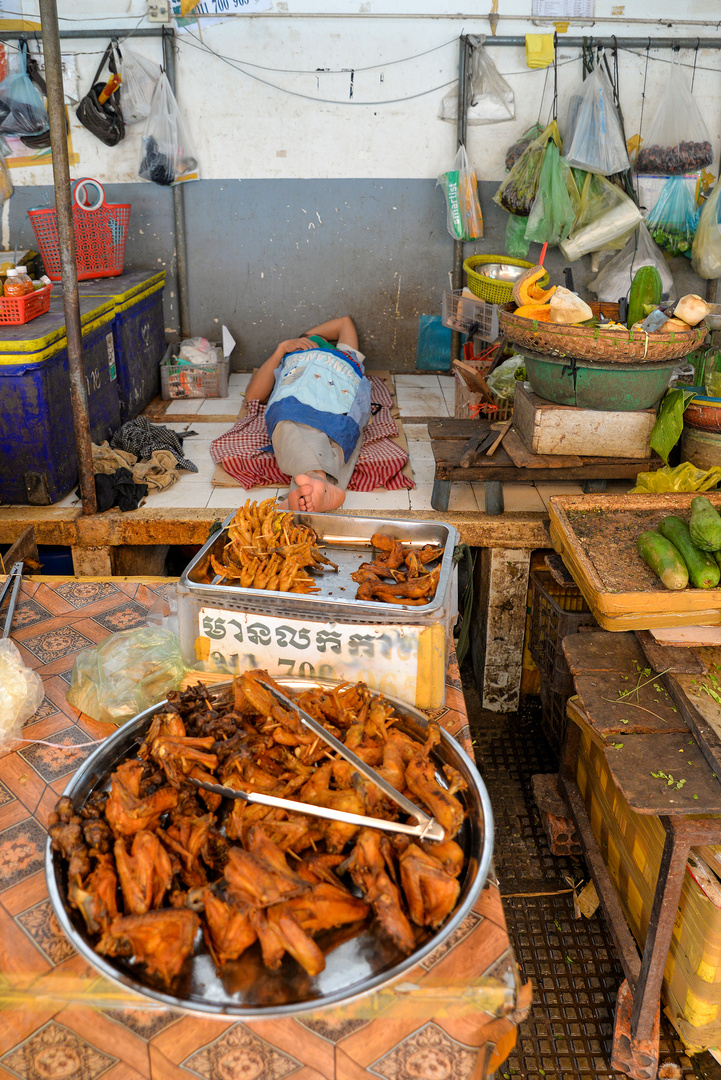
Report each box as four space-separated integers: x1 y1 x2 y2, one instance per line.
210 375 416 491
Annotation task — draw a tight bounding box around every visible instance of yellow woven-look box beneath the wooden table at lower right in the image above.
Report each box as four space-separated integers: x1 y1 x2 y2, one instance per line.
568 698 721 1051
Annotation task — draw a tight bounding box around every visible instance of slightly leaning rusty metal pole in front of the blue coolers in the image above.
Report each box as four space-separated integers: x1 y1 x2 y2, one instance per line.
40 0 97 514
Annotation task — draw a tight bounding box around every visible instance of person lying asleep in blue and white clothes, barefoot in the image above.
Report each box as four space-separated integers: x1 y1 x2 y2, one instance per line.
245 315 370 512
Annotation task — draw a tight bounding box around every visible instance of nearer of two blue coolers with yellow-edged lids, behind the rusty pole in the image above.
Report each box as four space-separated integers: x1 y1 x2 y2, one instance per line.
0 297 120 505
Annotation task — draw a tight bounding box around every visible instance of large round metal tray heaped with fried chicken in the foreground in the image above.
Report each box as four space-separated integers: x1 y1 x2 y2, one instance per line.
45 672 493 1018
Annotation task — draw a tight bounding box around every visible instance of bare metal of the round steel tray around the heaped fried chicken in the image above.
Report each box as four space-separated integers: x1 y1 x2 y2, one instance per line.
45 678 493 1020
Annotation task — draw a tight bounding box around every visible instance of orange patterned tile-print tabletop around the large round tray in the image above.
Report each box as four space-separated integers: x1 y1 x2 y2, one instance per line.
0 579 530 1080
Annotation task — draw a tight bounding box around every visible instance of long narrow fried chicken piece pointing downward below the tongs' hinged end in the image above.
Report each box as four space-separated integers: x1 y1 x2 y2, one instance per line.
344 828 416 954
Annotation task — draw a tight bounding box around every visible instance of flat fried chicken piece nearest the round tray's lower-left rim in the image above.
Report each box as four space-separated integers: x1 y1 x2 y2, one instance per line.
96 907 201 986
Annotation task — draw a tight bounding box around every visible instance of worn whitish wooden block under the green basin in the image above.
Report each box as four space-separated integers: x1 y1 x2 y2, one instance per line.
513 382 656 458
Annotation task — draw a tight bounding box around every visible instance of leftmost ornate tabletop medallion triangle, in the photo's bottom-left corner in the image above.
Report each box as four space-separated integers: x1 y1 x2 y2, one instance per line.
0 1021 118 1080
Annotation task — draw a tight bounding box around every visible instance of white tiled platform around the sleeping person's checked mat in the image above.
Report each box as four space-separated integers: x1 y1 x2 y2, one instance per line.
49 374 631 513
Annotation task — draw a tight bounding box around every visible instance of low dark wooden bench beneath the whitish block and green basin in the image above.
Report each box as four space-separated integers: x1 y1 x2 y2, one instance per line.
428 418 663 514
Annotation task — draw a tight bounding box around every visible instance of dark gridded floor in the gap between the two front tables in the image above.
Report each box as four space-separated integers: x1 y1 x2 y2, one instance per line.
462 665 721 1080
